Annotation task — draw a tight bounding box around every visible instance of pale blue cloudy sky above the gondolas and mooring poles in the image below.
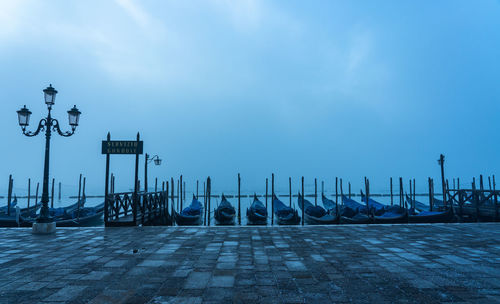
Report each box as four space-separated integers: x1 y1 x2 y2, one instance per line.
0 0 500 197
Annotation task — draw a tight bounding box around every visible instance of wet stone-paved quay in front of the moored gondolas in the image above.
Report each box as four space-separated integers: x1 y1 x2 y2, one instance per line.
0 223 500 303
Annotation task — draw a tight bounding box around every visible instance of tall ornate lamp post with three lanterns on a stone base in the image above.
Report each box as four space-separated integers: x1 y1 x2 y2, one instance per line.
17 85 81 233
